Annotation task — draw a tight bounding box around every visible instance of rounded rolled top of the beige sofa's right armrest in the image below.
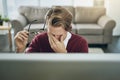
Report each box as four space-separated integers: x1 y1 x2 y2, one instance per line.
98 16 116 35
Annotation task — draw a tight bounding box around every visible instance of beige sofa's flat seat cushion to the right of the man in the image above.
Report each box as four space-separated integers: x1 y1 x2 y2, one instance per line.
75 24 103 35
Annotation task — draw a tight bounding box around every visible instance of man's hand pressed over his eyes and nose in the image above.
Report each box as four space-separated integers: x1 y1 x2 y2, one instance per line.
48 33 67 53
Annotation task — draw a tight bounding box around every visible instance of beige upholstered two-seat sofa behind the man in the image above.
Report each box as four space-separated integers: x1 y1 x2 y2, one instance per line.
11 6 116 44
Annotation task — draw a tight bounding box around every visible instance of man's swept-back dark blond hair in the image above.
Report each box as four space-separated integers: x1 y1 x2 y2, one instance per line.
46 6 72 31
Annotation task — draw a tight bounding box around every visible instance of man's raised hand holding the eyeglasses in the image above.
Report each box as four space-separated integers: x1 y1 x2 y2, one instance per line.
14 30 29 53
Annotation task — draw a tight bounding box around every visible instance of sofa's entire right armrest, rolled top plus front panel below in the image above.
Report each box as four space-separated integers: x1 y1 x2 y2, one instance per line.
98 16 116 43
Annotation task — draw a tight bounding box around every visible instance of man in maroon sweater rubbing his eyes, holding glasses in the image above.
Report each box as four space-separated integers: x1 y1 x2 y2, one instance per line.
15 6 88 53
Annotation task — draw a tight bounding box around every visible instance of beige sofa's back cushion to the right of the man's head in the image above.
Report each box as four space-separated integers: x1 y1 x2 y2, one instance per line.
75 7 105 23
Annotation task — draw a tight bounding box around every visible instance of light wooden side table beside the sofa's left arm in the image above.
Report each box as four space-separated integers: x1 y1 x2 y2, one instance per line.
0 26 12 49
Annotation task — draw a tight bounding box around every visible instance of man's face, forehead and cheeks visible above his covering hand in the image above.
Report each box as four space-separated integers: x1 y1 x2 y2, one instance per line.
47 26 67 41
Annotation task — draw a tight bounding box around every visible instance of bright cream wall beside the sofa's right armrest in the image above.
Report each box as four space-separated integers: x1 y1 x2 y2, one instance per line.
105 0 120 36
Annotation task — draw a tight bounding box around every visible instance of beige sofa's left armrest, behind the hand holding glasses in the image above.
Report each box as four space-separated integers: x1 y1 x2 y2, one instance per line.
11 15 27 34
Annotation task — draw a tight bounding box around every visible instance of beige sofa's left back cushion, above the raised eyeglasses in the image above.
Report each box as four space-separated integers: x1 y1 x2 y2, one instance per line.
19 6 49 23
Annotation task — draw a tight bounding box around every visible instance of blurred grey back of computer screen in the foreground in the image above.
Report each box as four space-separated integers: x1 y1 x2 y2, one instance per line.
0 54 120 80
